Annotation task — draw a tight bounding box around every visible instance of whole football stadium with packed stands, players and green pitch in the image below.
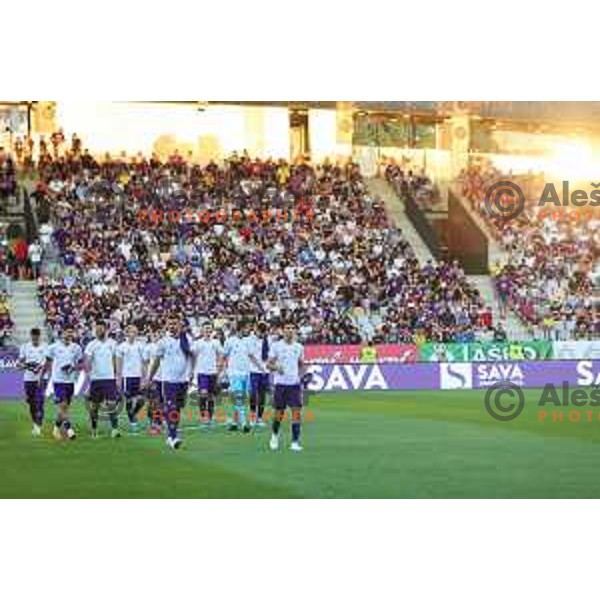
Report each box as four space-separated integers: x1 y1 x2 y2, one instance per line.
0 101 600 499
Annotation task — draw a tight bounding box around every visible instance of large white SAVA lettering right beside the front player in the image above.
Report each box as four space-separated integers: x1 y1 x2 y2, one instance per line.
309 365 388 392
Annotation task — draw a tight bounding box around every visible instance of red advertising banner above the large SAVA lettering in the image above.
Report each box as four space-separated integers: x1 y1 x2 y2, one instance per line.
304 344 418 364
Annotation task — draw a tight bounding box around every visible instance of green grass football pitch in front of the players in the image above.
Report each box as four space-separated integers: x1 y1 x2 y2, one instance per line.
0 390 600 498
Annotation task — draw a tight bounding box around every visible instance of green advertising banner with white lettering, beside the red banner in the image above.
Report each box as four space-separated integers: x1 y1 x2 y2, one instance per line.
419 342 553 362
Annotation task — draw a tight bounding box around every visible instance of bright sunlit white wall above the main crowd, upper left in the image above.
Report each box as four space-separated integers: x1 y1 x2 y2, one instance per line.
56 102 290 162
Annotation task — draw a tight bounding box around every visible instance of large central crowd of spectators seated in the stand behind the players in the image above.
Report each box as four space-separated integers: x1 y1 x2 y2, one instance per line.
37 141 489 343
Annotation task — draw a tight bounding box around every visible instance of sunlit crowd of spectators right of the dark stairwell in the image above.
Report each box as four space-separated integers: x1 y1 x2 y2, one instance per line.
460 162 600 340
